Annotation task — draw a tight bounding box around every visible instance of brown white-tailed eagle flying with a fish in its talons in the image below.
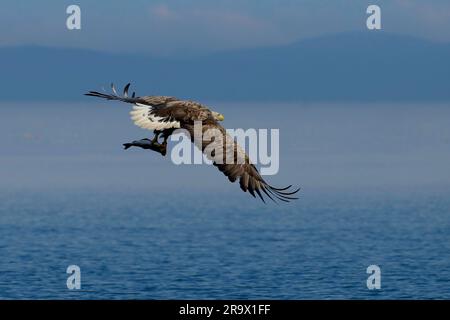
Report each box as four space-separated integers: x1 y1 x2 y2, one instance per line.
85 83 300 203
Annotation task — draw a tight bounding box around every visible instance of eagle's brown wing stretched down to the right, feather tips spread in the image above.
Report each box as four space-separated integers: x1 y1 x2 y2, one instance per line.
182 122 300 202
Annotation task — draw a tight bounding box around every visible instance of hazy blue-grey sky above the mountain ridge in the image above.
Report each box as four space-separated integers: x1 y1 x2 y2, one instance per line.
0 0 450 56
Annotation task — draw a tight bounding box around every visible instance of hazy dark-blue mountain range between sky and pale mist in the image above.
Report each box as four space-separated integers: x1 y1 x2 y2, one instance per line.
0 31 450 101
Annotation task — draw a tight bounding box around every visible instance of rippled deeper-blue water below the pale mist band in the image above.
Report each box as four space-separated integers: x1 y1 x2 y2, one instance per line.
0 192 450 299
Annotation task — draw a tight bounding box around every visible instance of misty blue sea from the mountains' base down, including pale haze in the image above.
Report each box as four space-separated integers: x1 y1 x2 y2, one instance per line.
0 102 450 299
